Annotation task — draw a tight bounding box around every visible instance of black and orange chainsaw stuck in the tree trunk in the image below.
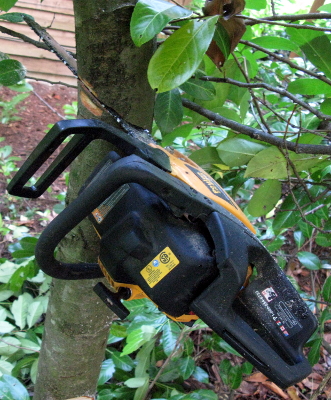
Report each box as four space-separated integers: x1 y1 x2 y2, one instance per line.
8 119 317 388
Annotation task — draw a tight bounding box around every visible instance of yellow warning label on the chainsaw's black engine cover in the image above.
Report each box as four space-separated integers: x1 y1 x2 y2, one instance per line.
140 247 179 287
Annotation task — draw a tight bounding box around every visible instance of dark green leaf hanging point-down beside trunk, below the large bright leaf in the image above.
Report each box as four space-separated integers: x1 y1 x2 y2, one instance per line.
154 88 183 133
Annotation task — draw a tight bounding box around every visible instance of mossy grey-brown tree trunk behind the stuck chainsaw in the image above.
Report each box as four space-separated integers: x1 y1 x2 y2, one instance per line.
34 0 154 400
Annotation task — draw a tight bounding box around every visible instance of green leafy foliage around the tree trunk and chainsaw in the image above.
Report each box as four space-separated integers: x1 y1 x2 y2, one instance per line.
0 0 331 400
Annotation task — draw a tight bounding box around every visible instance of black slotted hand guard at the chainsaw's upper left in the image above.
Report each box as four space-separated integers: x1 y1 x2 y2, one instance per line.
7 119 171 198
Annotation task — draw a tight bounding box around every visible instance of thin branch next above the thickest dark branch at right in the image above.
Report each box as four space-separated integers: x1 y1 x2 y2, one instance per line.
200 76 331 121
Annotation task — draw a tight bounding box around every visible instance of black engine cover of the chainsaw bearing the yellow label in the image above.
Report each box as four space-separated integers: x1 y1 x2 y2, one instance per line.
91 180 218 317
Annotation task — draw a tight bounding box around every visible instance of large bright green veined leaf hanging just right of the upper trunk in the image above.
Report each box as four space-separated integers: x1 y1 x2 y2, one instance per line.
147 15 218 93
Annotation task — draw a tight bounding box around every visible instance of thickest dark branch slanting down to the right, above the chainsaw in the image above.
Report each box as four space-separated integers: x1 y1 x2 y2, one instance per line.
182 98 331 155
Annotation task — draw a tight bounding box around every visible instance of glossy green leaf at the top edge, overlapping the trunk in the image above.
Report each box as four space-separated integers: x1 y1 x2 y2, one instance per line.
130 0 192 46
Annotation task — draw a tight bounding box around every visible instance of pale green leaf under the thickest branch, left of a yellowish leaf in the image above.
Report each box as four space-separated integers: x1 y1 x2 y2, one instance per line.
217 137 265 167
